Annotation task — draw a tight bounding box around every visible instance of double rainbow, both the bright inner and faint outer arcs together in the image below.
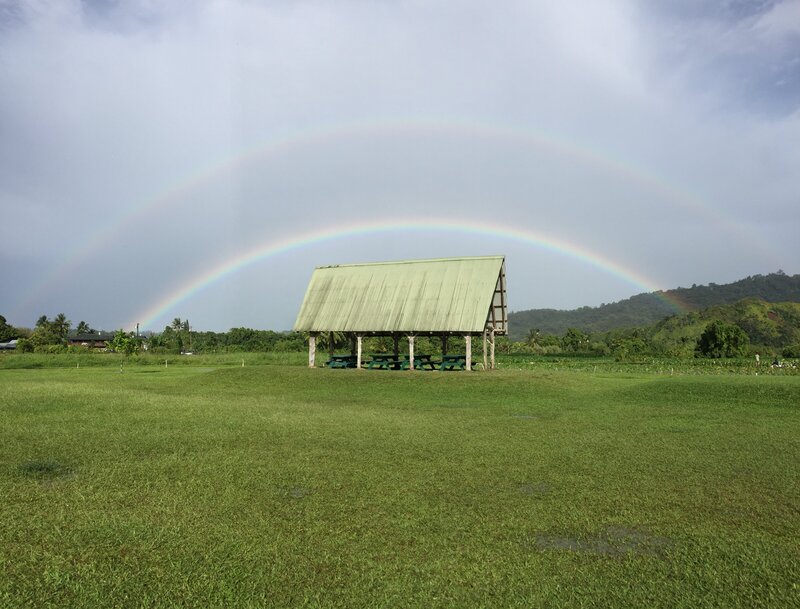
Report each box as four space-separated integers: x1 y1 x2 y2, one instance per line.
12 118 756 319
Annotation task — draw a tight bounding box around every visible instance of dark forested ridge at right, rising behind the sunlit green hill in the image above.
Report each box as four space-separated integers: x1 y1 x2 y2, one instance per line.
508 271 800 340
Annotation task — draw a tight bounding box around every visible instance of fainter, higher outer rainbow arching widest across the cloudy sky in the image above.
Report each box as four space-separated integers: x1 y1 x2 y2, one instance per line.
16 118 776 320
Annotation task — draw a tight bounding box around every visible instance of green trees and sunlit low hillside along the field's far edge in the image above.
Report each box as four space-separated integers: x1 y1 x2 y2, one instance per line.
0 299 800 360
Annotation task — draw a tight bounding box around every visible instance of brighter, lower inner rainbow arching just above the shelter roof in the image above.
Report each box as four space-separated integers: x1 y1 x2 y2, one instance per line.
130 219 686 328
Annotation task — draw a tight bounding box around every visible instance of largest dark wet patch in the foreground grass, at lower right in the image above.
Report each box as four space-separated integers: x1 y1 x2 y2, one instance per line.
532 525 670 557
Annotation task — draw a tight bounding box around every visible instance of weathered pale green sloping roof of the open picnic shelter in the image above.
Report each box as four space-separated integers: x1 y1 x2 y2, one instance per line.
294 256 507 333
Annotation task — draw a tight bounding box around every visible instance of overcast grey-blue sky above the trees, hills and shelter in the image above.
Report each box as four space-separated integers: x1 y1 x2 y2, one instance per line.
0 0 800 330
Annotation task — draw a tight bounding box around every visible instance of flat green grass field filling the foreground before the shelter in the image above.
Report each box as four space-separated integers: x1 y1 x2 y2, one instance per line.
0 359 800 608
